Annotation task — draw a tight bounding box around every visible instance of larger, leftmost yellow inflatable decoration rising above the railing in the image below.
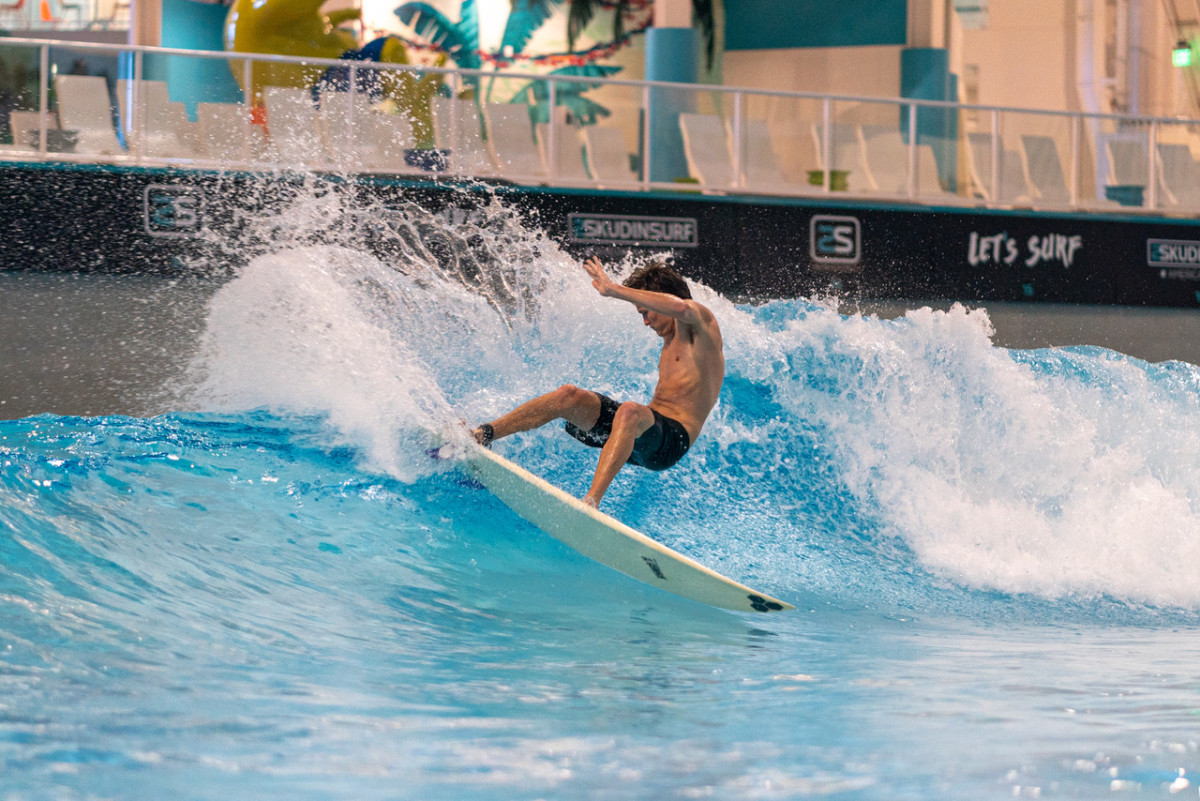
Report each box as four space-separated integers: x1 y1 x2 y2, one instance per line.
224 0 361 106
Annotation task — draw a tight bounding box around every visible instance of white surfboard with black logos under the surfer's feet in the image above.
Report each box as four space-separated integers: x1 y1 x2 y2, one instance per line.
467 447 794 612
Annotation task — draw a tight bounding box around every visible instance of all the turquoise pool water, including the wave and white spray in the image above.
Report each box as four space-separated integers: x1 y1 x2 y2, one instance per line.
0 208 1200 801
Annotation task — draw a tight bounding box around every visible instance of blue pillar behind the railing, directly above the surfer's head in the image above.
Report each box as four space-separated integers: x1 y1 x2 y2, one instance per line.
643 28 698 181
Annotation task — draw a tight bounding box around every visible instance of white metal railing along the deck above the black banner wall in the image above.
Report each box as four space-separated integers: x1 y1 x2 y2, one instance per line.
7 37 1200 211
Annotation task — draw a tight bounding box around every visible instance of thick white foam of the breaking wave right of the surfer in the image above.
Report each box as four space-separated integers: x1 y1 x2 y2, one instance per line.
724 299 1200 608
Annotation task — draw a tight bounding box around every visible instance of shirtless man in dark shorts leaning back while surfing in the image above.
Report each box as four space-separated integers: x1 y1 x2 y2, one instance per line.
472 257 725 506
